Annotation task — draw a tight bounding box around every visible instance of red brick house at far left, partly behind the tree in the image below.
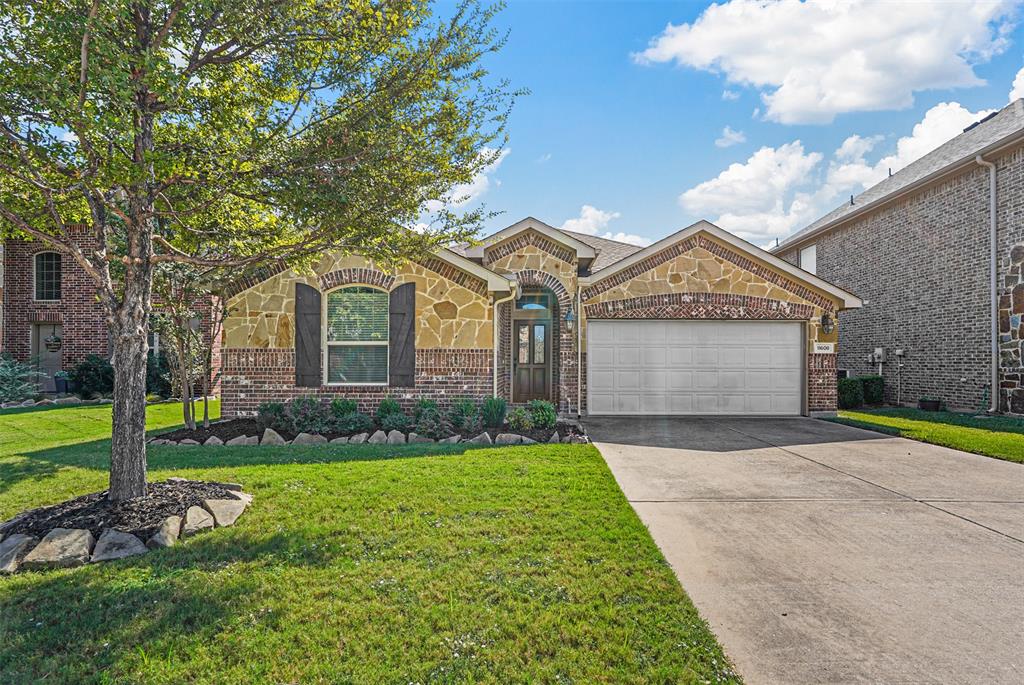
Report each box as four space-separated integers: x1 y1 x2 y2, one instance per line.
0 226 220 392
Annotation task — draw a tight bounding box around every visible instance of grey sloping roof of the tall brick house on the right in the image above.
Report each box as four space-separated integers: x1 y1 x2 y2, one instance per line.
772 99 1024 253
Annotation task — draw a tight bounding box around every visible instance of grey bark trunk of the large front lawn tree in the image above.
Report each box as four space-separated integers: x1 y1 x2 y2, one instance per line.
109 296 148 502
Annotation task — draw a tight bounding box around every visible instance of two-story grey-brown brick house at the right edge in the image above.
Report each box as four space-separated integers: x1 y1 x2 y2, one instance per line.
772 100 1024 414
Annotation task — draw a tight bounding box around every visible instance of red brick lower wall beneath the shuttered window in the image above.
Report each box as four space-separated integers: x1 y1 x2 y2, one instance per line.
221 348 493 417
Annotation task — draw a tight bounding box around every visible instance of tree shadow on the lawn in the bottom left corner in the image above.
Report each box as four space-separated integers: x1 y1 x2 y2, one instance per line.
0 529 338 683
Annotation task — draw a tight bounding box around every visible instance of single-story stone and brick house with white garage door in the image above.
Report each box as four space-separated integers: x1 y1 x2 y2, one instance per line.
221 218 860 417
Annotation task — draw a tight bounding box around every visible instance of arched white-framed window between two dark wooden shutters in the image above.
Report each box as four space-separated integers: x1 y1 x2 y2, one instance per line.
324 286 389 385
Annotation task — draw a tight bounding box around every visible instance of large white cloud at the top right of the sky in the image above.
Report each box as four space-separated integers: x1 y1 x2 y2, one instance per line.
634 0 1018 124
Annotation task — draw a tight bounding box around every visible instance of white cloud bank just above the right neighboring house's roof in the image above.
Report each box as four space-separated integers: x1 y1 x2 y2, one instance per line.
679 102 989 244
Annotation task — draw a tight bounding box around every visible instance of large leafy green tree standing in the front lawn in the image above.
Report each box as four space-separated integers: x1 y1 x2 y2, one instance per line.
0 0 514 500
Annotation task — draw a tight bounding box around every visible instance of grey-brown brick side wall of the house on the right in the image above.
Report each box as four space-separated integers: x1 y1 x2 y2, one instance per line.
779 144 1024 414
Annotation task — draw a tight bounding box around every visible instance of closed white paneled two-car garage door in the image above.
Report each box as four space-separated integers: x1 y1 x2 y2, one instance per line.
587 319 804 415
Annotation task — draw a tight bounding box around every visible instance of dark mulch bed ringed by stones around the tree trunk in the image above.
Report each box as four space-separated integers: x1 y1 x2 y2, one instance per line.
3 480 236 541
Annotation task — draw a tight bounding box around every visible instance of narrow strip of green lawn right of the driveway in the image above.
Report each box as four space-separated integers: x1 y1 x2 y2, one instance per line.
831 409 1024 463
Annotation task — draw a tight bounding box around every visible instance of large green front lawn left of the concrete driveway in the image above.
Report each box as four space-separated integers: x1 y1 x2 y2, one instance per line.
0 404 736 684
